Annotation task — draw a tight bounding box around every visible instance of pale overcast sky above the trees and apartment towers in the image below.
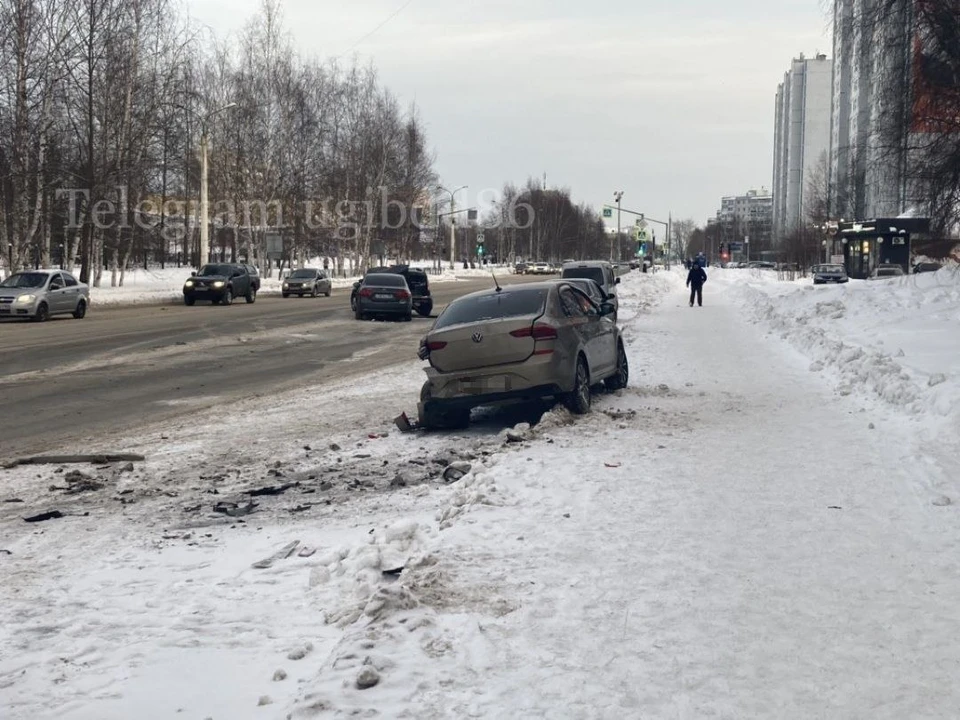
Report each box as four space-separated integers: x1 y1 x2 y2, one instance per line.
189 0 831 223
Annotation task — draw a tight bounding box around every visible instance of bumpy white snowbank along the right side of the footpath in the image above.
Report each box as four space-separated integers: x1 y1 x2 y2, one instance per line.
728 268 960 424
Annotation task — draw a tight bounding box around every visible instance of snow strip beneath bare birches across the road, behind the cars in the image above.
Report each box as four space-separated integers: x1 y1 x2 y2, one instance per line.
61 261 509 305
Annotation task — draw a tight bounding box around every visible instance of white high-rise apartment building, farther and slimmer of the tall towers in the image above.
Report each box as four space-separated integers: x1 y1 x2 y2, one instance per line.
773 54 834 241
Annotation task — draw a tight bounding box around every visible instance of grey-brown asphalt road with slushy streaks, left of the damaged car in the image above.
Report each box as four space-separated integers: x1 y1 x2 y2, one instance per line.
0 276 536 460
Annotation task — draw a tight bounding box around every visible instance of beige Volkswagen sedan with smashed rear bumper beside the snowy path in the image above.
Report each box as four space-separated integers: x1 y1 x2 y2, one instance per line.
418 280 629 429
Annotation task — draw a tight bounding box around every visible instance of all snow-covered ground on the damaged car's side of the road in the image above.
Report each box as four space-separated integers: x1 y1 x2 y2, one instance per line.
0 271 960 720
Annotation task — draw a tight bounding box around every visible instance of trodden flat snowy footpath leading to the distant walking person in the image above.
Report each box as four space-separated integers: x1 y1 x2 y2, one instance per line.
344 272 960 720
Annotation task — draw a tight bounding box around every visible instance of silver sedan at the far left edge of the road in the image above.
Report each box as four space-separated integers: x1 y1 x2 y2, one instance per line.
0 270 90 322
